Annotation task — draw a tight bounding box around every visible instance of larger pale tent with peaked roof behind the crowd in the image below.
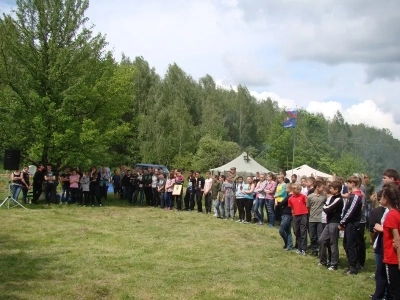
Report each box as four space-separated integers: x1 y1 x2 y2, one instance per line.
210 152 271 176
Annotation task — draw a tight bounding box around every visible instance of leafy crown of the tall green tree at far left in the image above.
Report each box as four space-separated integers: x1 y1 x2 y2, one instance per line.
0 0 133 166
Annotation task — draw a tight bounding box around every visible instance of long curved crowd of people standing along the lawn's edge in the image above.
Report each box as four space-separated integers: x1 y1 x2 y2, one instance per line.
7 165 400 299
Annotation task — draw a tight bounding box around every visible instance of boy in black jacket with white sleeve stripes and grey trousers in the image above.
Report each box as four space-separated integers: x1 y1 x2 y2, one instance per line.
318 180 344 271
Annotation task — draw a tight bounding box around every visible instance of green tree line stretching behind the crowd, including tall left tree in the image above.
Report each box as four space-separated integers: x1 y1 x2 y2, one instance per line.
0 0 400 181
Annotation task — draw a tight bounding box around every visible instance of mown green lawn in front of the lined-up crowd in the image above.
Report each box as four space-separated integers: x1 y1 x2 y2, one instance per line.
0 200 374 299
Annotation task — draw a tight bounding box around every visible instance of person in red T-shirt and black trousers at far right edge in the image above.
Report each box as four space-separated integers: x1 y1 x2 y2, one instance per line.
375 182 400 299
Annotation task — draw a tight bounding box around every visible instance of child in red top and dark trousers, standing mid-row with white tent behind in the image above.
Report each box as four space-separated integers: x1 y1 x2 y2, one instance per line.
288 184 308 255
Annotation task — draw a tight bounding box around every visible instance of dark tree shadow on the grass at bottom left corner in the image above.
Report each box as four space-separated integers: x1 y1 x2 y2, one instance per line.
0 233 56 299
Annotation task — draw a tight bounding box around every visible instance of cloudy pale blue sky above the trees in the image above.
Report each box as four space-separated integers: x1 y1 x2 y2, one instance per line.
0 0 400 139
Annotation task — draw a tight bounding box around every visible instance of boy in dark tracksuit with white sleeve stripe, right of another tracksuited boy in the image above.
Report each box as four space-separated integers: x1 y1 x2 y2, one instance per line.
339 176 363 275
